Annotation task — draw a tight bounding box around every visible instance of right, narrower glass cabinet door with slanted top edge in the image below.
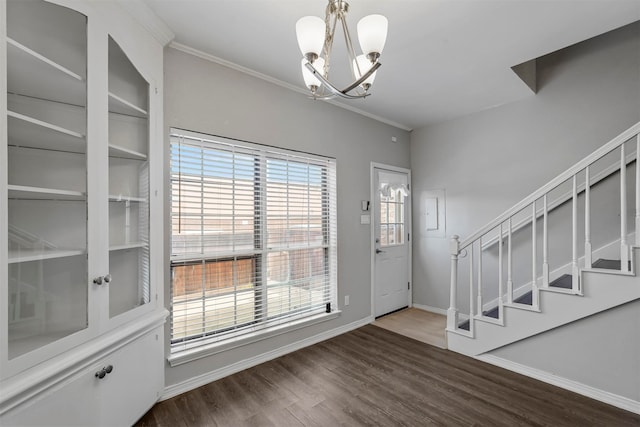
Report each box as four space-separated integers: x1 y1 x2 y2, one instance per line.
109 37 150 318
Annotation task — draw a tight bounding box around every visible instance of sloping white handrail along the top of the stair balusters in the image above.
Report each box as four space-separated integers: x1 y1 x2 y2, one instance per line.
458 122 640 250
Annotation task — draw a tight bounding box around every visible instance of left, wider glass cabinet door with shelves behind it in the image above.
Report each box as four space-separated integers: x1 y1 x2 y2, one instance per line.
1 0 88 359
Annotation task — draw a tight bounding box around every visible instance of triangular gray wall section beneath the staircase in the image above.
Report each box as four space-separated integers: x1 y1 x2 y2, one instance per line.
491 301 640 402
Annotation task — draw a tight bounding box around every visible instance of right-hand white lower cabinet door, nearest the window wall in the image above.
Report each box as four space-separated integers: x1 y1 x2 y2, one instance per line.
98 327 164 426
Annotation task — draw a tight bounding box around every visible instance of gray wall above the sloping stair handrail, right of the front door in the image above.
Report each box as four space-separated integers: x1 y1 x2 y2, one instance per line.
411 23 640 309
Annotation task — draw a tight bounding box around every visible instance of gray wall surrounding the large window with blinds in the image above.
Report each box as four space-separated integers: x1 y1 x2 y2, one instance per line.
164 48 410 386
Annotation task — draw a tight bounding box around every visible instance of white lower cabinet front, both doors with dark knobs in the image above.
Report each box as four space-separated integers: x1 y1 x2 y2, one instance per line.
0 326 164 427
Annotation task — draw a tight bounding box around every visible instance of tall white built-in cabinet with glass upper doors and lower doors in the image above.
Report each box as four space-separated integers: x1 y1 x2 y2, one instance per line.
0 0 166 425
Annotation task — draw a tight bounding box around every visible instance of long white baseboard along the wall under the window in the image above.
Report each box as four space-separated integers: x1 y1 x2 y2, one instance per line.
160 316 374 401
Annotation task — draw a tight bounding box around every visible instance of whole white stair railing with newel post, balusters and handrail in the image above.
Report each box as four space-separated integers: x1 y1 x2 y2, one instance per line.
447 122 640 336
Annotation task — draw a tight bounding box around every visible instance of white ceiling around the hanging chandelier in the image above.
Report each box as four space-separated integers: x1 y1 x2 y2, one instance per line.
144 0 640 130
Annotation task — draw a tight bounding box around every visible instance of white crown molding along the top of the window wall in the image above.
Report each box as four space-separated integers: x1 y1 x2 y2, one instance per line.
169 42 413 132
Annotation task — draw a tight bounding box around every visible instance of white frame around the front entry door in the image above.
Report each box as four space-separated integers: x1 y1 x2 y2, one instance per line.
369 162 413 319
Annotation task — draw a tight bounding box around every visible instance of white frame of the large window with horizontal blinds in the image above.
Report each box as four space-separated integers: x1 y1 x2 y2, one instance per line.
169 128 340 365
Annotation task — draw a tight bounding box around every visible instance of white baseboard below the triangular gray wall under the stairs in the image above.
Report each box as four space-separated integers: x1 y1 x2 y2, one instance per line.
474 354 640 415
